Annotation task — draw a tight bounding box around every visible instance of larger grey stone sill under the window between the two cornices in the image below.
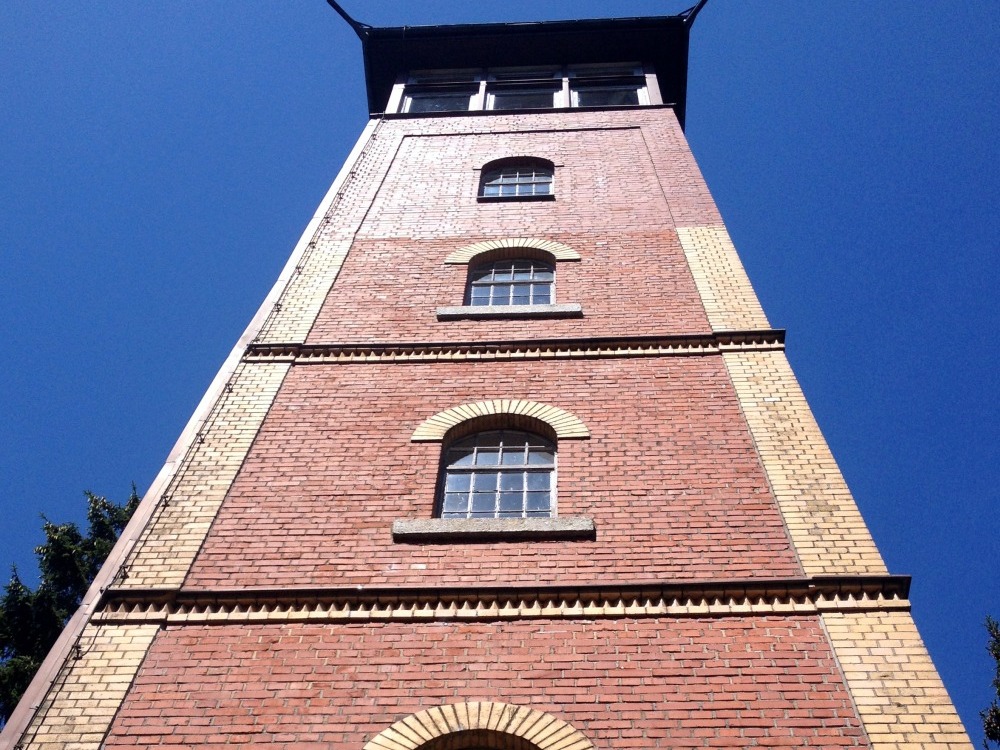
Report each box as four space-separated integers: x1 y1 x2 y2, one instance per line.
392 516 597 544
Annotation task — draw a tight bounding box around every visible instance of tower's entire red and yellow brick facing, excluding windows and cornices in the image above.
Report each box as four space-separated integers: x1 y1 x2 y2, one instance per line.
3 88 969 750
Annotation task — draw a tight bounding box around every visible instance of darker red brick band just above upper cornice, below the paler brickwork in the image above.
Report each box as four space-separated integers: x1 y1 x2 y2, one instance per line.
308 231 711 344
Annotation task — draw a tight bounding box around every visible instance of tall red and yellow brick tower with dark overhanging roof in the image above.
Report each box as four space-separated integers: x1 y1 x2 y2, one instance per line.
3 11 970 750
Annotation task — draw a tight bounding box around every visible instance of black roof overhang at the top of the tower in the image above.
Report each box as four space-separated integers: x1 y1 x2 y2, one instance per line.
358 15 690 124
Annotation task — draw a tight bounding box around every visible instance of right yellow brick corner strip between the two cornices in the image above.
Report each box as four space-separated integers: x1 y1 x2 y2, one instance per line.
722 351 886 576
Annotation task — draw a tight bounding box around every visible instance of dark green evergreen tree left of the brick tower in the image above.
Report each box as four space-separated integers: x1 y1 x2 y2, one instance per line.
0 484 139 727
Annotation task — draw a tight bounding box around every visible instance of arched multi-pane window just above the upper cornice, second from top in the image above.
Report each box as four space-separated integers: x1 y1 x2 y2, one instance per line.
466 258 555 307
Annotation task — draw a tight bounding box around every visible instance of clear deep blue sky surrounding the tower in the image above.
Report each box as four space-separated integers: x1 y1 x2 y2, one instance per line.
0 0 1000 744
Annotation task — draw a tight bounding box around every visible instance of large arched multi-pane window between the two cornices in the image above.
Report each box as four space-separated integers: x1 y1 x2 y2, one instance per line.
438 430 556 518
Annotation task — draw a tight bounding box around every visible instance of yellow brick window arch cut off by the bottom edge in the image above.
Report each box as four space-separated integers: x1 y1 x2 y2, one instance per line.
364 702 594 750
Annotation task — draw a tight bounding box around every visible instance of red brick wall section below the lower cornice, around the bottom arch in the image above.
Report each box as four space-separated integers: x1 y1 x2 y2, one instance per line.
106 616 868 750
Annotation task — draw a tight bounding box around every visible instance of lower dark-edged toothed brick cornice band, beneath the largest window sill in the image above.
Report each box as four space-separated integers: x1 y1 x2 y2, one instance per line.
95 576 910 625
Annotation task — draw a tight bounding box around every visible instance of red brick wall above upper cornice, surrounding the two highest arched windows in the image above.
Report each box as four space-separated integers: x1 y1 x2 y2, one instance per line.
309 110 719 343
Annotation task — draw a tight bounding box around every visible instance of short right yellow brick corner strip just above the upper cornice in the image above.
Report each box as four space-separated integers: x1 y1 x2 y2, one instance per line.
677 224 770 331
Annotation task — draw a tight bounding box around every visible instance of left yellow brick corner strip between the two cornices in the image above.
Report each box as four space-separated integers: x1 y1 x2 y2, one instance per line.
116 362 291 588
